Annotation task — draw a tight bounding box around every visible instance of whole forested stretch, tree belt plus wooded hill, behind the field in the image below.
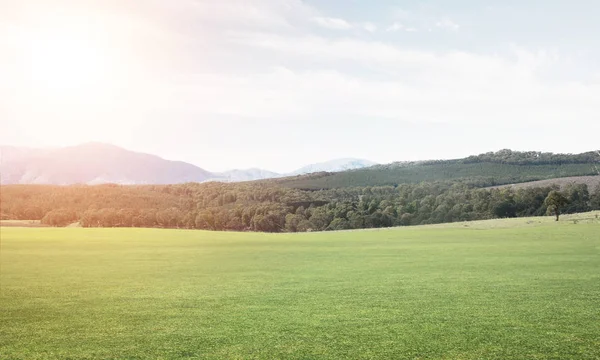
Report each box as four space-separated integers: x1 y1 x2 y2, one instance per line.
0 150 600 232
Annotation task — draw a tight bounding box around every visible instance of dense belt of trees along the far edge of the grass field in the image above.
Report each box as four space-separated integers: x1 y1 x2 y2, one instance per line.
1 181 600 232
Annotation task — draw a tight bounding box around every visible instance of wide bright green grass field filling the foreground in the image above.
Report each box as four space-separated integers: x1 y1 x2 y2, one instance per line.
0 214 600 359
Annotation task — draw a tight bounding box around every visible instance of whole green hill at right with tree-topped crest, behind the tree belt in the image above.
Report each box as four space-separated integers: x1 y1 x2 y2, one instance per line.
276 150 600 189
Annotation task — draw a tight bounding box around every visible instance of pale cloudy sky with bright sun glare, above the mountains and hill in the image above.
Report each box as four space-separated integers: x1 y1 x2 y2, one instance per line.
0 0 600 172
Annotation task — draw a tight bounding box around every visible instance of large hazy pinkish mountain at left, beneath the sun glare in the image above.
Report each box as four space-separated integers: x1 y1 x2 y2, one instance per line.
0 143 212 185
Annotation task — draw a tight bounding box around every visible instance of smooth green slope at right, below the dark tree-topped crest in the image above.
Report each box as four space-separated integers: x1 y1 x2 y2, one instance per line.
275 161 596 189
